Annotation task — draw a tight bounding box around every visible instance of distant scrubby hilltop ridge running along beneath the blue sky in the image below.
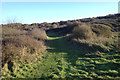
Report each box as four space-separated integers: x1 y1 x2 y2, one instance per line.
2 13 120 30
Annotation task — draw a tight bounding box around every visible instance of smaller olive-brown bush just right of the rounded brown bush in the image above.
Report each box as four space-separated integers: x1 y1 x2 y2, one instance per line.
92 24 112 38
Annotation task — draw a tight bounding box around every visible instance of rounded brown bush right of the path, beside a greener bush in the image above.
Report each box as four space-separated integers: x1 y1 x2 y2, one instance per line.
73 24 95 39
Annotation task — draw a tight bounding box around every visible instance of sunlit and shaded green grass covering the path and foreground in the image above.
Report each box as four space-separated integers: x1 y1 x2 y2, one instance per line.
3 33 120 79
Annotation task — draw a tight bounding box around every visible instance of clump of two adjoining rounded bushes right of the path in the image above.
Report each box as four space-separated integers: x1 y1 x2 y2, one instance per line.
72 24 116 52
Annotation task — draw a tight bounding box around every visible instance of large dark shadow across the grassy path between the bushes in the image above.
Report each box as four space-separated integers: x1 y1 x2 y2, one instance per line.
47 33 104 65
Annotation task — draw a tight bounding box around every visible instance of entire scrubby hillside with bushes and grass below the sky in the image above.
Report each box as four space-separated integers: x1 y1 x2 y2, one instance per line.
2 14 120 79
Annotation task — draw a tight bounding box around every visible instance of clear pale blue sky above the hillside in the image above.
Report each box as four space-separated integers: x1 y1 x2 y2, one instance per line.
1 2 118 24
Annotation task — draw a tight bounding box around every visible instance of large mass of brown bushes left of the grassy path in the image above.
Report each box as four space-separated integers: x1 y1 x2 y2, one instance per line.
2 27 47 66
